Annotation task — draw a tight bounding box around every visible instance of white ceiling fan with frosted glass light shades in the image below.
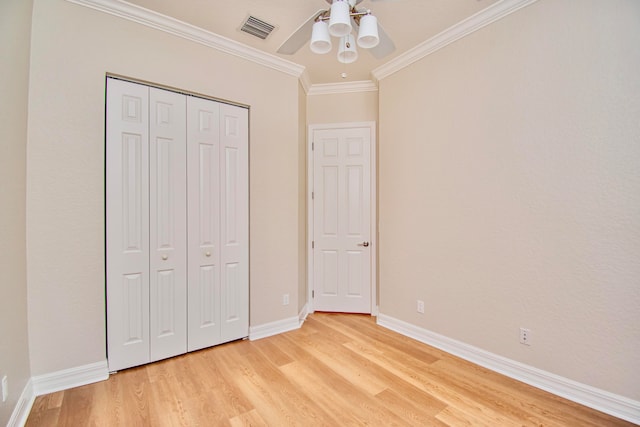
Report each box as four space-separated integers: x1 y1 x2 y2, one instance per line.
278 0 396 62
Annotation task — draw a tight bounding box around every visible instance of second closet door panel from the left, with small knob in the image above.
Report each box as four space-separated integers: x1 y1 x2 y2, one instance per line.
149 88 187 361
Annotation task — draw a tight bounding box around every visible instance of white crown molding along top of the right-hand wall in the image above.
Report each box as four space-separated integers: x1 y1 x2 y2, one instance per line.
371 0 538 81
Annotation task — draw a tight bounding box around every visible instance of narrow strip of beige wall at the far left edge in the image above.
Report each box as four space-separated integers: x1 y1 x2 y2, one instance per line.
0 0 33 425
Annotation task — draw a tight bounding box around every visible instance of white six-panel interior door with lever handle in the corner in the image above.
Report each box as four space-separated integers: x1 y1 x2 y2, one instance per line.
312 126 373 313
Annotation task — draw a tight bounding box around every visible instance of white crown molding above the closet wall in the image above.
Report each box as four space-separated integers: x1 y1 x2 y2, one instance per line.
67 0 304 77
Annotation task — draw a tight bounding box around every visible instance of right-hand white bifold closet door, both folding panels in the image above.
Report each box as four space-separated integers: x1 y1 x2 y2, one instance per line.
187 97 249 351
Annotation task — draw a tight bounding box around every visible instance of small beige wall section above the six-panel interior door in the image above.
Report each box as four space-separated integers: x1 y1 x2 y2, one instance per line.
307 91 378 125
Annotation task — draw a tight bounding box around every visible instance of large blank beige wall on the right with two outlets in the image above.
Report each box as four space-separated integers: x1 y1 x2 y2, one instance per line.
379 0 640 400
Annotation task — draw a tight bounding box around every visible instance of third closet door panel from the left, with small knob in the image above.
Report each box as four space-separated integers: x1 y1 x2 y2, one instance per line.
187 97 221 351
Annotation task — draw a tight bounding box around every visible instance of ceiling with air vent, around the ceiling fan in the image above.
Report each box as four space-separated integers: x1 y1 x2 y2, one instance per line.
128 0 499 85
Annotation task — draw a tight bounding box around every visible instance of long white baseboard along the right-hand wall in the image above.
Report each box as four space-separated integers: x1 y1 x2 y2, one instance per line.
377 314 640 424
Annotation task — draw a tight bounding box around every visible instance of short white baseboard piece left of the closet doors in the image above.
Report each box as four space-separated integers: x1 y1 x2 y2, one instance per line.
31 360 109 396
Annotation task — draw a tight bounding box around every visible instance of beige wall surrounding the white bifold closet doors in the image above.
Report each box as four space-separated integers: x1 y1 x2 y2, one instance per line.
27 0 299 375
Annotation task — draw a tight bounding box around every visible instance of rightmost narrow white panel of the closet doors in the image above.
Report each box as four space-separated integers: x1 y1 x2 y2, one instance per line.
220 104 249 342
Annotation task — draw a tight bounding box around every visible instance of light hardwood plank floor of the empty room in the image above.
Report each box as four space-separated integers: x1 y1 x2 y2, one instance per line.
26 313 632 427
